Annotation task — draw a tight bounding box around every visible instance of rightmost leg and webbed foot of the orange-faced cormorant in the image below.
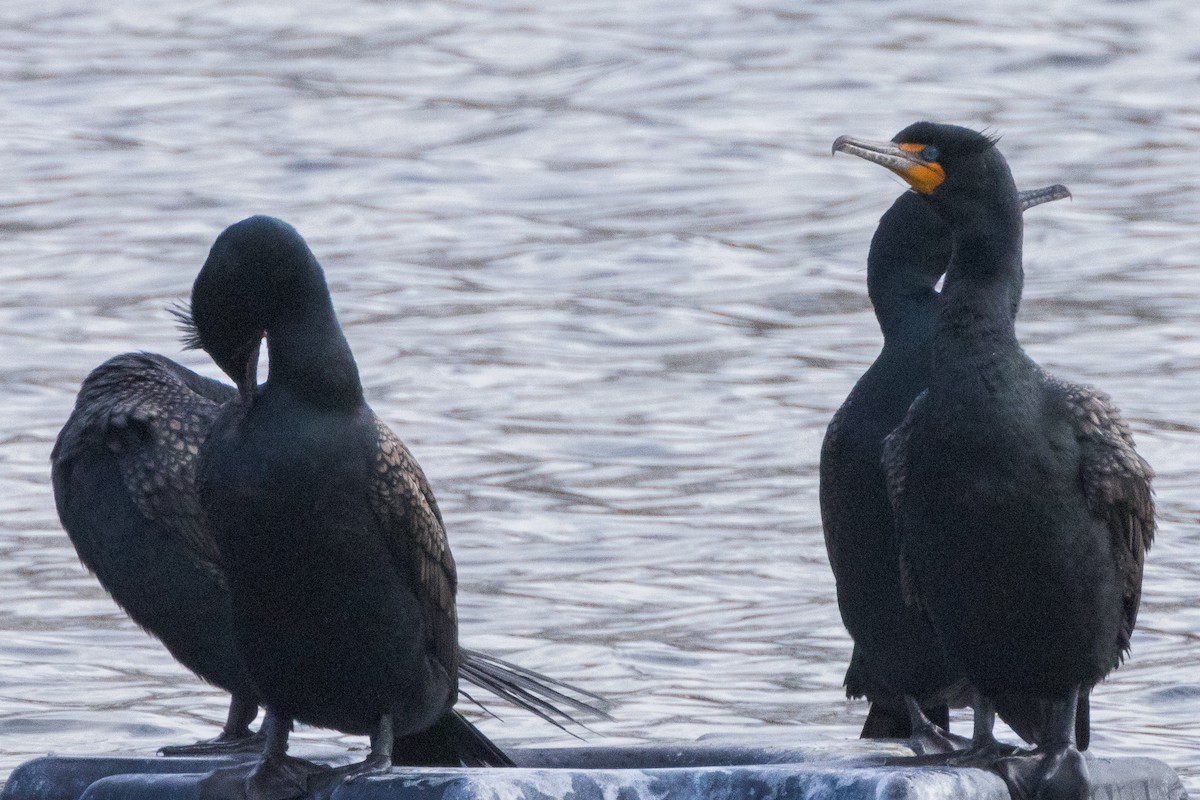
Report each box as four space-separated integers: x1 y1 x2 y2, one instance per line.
994 686 1091 800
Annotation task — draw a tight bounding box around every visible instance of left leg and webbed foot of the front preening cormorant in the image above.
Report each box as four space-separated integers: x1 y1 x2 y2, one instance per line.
199 709 329 800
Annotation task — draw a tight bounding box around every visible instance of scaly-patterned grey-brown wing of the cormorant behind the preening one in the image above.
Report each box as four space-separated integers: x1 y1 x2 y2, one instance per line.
50 353 231 585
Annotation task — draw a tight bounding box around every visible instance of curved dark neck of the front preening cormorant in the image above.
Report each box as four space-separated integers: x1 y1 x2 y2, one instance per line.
266 291 362 409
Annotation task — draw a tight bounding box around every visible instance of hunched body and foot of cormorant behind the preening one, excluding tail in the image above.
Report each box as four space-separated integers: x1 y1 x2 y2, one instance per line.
50 353 258 752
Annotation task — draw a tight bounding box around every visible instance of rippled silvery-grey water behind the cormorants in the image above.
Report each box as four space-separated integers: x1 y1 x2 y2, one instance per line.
0 0 1200 790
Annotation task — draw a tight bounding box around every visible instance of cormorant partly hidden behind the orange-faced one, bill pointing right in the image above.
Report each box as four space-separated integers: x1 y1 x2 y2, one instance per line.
821 185 1070 752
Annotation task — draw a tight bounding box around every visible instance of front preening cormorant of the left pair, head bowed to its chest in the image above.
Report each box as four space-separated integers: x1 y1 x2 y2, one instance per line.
191 217 523 798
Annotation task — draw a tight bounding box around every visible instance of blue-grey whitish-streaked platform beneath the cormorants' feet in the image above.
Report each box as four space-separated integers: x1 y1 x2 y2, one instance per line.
0 741 1187 800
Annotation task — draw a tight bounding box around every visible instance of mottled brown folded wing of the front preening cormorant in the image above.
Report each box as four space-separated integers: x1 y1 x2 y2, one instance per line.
371 419 458 679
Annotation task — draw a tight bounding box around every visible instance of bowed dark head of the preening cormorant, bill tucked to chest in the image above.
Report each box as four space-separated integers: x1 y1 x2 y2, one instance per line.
190 216 329 402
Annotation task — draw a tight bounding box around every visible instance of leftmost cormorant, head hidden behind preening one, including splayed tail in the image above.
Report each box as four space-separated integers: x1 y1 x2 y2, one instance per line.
52 215 604 786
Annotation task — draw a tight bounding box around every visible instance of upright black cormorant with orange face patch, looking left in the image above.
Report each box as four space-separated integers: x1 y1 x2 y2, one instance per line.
834 122 1154 800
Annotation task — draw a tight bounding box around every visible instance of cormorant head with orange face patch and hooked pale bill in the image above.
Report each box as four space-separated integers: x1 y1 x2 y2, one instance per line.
833 122 1046 223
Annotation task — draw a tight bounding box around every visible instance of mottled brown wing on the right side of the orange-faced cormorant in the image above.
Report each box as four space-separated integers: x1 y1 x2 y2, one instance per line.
1050 378 1154 652
